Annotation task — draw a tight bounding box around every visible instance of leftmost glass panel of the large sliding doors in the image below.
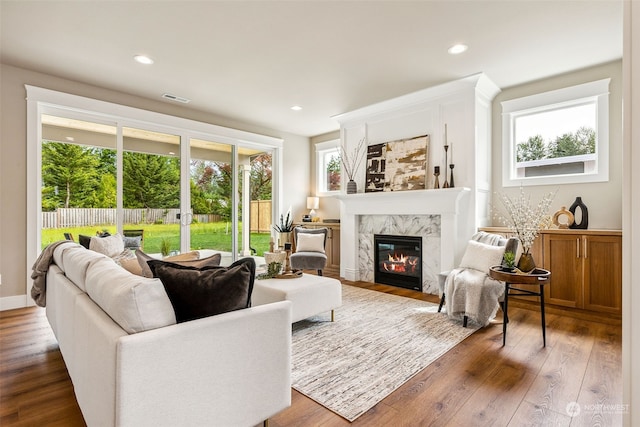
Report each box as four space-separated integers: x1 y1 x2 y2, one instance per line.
40 114 117 247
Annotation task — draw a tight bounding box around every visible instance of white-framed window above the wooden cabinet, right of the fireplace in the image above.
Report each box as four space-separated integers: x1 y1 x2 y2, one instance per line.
502 79 610 187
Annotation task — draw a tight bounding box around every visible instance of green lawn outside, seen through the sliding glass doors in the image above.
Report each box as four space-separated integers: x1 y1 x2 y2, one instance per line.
42 222 270 255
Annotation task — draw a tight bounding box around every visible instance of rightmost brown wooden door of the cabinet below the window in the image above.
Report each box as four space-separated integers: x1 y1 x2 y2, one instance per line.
584 236 622 313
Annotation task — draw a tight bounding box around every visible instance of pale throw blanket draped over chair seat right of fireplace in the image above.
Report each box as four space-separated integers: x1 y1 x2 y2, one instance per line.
445 268 504 326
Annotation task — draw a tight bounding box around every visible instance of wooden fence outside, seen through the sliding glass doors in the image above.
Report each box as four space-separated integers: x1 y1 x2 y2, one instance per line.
42 200 271 233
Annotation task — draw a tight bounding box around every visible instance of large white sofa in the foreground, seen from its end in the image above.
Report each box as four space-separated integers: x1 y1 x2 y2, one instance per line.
40 243 291 427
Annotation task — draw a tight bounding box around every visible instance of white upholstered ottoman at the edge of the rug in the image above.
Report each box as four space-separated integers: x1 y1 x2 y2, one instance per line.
251 274 342 322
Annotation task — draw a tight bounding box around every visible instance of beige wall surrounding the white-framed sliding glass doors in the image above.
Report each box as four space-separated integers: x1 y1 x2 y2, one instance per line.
0 64 309 309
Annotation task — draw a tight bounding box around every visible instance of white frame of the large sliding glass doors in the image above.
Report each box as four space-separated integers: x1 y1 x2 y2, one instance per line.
25 85 284 305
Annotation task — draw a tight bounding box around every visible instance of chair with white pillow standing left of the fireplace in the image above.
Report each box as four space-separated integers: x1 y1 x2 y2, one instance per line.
289 227 328 276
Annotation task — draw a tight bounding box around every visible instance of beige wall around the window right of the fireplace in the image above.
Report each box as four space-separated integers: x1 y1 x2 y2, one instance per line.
492 61 623 230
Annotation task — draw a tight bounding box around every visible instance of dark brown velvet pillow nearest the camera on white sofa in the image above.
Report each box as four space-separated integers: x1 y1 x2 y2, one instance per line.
148 258 256 323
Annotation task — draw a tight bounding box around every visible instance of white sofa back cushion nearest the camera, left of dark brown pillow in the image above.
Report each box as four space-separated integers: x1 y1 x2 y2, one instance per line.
86 257 176 334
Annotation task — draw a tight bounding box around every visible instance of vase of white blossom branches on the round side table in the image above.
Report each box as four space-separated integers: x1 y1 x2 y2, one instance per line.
495 187 555 273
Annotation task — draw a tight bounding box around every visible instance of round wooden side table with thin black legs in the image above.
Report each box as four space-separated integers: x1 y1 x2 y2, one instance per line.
489 265 551 347
